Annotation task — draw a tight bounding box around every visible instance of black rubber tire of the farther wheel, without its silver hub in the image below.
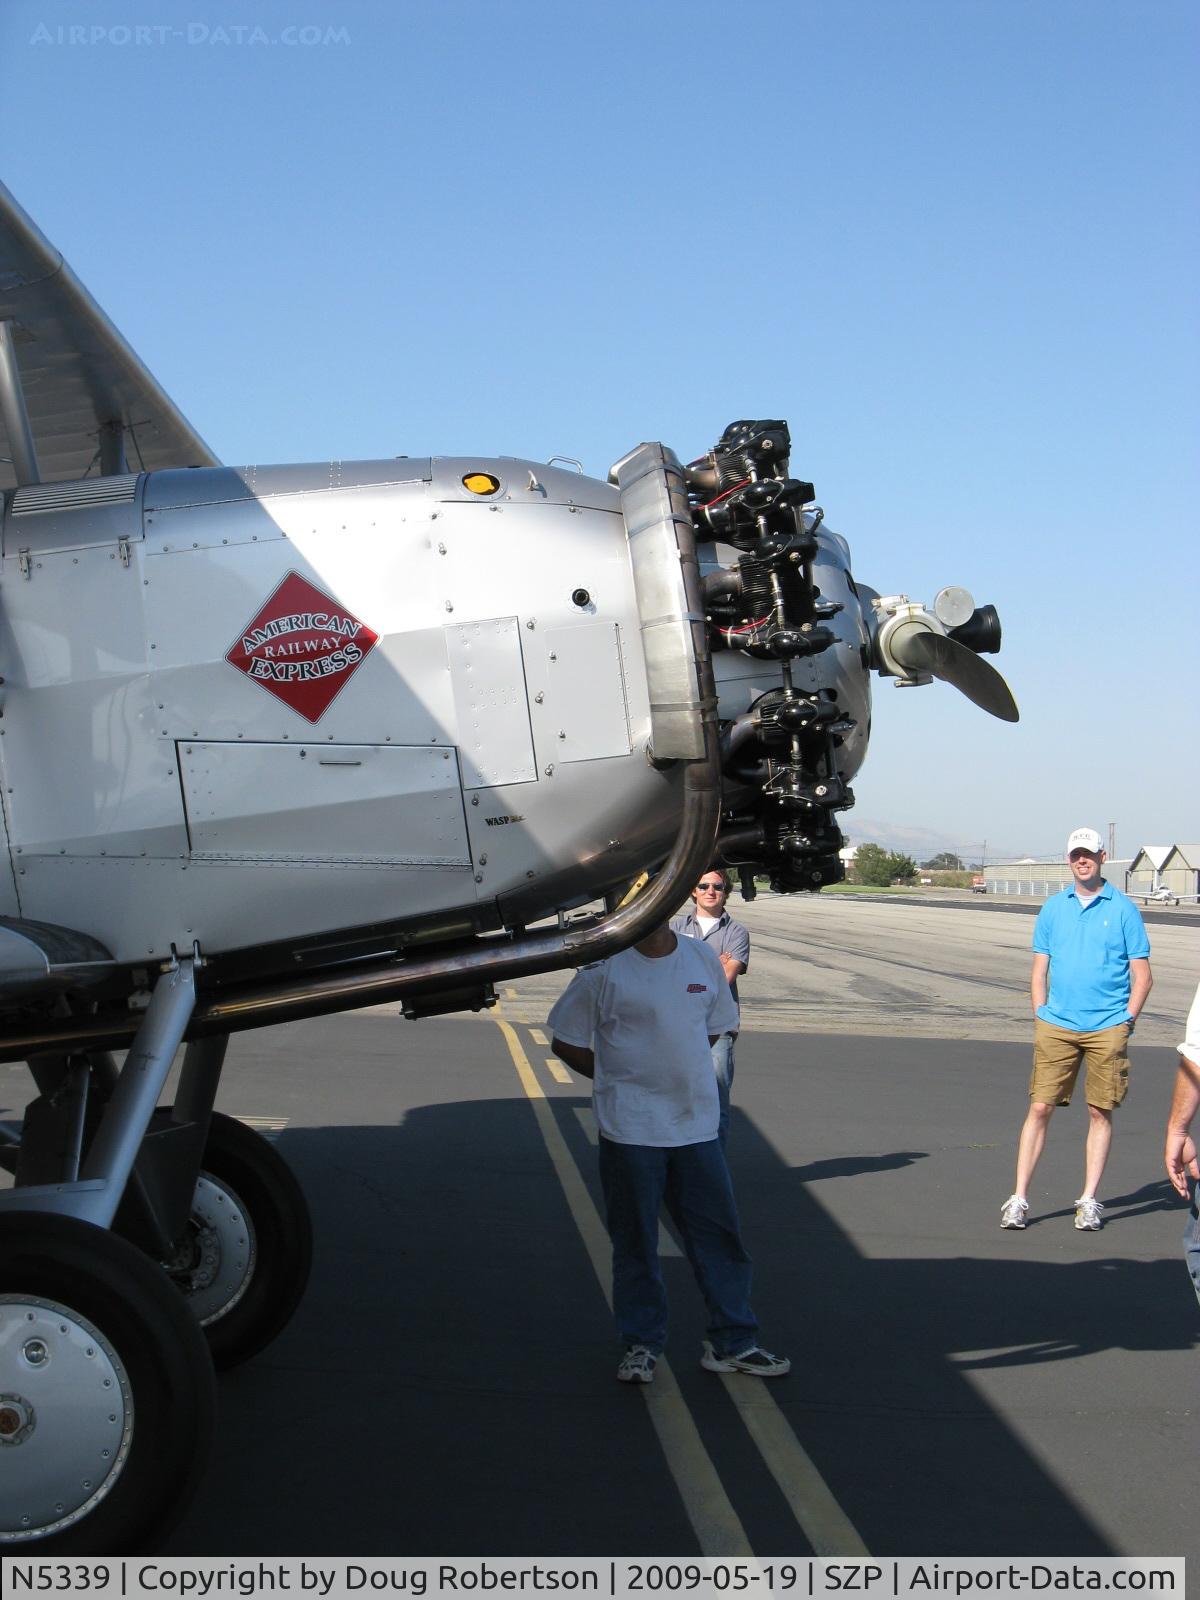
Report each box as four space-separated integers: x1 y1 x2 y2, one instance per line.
170 1112 312 1368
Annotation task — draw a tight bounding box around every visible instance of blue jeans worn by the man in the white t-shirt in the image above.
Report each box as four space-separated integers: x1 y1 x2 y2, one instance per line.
600 1134 758 1357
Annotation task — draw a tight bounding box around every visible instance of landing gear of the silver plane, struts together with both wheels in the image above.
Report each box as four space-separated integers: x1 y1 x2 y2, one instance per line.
0 960 312 1555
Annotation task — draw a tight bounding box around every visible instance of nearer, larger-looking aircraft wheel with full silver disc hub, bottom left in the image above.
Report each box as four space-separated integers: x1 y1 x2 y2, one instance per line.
0 1211 216 1555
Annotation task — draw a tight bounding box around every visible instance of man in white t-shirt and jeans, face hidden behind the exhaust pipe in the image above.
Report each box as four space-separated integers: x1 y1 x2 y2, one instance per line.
549 923 790 1384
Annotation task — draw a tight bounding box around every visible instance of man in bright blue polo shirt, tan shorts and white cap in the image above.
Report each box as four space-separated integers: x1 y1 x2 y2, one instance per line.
1000 827 1154 1232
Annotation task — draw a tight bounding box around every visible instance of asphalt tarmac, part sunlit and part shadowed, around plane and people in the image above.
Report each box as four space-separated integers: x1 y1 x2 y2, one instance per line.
0 898 1200 1558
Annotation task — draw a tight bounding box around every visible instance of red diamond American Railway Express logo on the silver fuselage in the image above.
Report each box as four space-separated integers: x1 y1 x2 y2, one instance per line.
226 573 379 722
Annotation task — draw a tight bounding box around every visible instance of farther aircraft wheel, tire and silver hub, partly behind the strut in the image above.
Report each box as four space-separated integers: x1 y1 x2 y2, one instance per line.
166 1112 312 1368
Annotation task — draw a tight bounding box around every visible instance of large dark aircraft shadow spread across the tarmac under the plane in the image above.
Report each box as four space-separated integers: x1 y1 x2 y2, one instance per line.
166 1086 1195 1557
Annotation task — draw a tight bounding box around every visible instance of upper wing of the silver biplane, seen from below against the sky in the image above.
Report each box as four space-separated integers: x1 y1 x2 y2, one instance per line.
0 184 219 488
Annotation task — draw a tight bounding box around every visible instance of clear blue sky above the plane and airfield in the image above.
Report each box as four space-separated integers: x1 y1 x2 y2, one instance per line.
0 0 1200 854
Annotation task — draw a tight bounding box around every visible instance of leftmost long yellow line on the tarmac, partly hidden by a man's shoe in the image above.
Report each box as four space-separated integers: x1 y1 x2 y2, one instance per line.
493 1018 754 1555
